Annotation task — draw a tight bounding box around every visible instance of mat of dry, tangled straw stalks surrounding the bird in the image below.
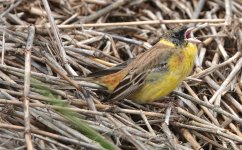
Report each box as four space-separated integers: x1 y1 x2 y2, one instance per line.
0 0 242 150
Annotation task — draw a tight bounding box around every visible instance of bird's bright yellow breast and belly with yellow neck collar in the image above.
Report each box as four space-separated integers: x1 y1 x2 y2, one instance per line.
129 40 197 103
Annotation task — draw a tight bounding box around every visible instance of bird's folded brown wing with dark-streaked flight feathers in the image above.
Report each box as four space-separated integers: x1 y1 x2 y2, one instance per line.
108 43 176 100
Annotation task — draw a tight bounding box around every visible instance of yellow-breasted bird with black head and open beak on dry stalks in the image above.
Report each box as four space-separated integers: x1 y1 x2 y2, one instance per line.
89 26 201 104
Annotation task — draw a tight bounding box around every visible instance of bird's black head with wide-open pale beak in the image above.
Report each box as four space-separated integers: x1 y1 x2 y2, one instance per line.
163 26 201 46
